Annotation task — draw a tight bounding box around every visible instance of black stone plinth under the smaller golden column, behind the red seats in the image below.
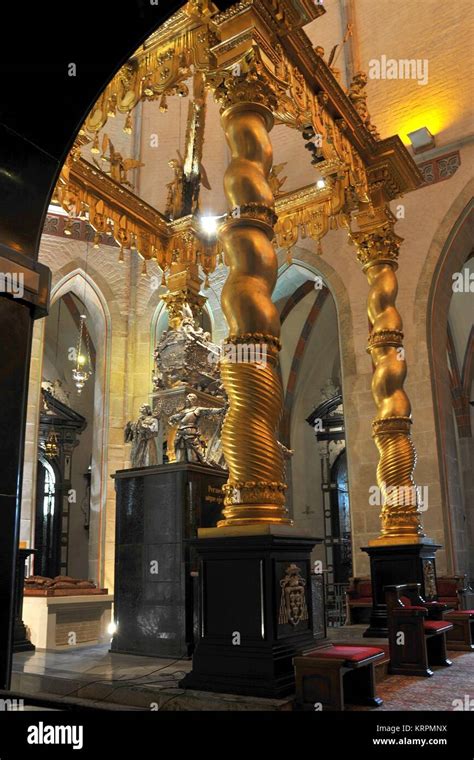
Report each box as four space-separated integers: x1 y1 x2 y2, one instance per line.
361 542 440 638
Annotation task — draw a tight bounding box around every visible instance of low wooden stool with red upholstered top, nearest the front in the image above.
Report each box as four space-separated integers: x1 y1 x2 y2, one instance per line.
293 644 385 712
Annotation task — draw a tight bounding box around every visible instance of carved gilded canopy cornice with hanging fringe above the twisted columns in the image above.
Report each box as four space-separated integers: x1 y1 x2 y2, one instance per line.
53 0 423 274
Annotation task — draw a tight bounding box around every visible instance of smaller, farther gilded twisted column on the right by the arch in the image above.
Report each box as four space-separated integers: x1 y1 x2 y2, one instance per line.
352 211 426 545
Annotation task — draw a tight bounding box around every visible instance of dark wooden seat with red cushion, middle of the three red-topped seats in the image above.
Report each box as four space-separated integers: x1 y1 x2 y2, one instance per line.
385 583 453 676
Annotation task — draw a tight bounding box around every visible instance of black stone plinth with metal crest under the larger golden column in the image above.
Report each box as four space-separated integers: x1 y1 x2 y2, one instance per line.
180 528 325 698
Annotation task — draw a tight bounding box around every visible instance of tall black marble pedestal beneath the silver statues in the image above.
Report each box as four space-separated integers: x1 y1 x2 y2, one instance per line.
111 463 227 658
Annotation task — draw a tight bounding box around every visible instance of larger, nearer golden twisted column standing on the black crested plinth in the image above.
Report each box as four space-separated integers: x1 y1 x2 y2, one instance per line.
215 73 291 527
